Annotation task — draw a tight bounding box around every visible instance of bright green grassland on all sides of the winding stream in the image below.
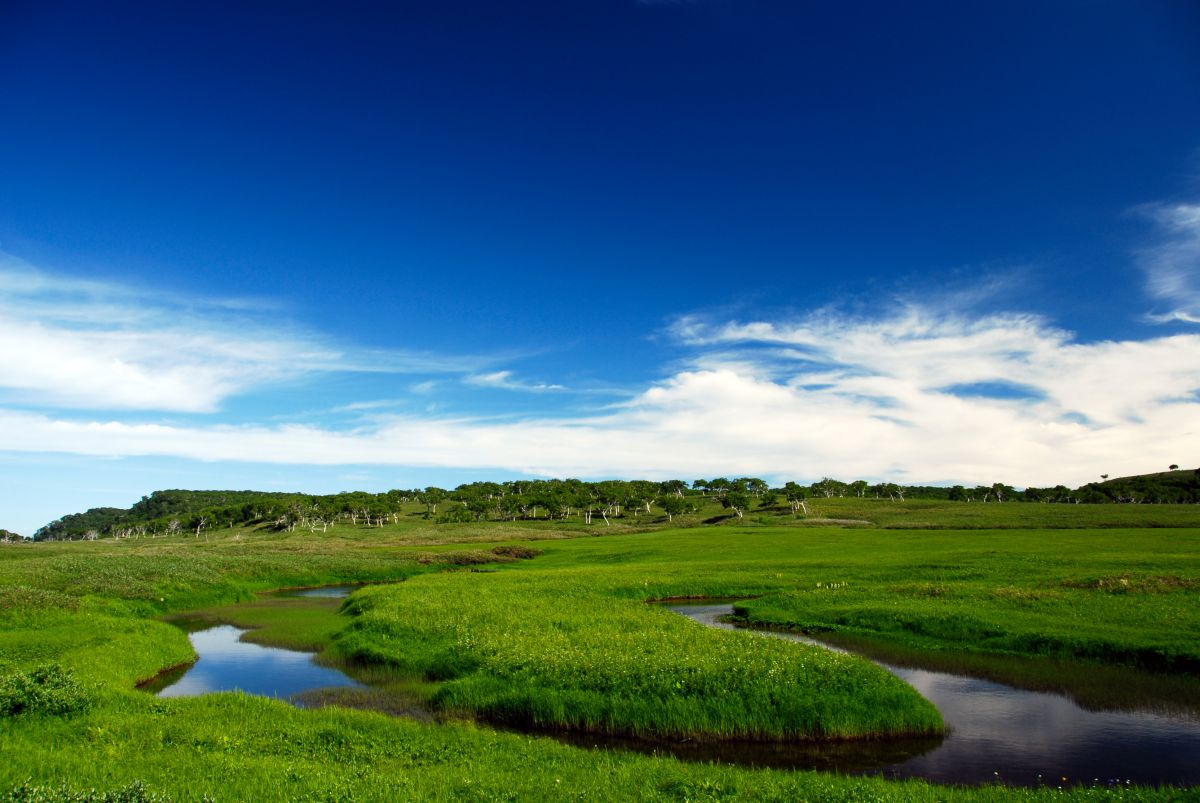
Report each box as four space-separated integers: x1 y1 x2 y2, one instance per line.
0 498 1200 801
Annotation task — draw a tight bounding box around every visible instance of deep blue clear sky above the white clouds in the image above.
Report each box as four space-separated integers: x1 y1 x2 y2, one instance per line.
0 0 1200 526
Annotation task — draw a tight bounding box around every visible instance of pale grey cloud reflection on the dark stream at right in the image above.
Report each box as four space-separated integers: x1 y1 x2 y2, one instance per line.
672 605 1200 786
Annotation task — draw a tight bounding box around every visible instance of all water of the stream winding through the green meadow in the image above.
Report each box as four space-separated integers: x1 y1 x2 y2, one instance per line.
148 586 1200 786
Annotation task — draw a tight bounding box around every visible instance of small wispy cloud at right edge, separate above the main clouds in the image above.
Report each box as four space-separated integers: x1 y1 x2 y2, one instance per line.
1139 203 1200 323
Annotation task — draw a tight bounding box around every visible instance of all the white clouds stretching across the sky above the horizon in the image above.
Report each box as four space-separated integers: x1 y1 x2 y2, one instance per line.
0 235 1200 494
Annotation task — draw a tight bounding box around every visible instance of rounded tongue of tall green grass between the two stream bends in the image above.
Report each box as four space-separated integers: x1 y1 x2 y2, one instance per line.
337 570 943 741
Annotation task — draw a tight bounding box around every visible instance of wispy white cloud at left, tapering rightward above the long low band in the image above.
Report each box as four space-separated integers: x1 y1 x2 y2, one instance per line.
0 258 484 413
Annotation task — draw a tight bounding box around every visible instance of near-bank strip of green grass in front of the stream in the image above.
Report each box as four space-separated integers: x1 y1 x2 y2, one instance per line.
0 693 1188 803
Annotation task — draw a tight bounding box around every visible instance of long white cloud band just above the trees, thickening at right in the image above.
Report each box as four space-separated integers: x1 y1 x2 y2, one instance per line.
0 307 1200 485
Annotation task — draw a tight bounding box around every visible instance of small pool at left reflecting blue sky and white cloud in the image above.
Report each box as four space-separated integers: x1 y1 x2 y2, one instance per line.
158 624 360 699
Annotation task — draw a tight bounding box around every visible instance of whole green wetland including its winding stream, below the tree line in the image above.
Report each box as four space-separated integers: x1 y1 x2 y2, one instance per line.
0 496 1200 799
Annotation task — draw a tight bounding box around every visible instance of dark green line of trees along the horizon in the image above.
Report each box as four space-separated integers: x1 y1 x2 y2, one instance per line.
30 467 1200 540
